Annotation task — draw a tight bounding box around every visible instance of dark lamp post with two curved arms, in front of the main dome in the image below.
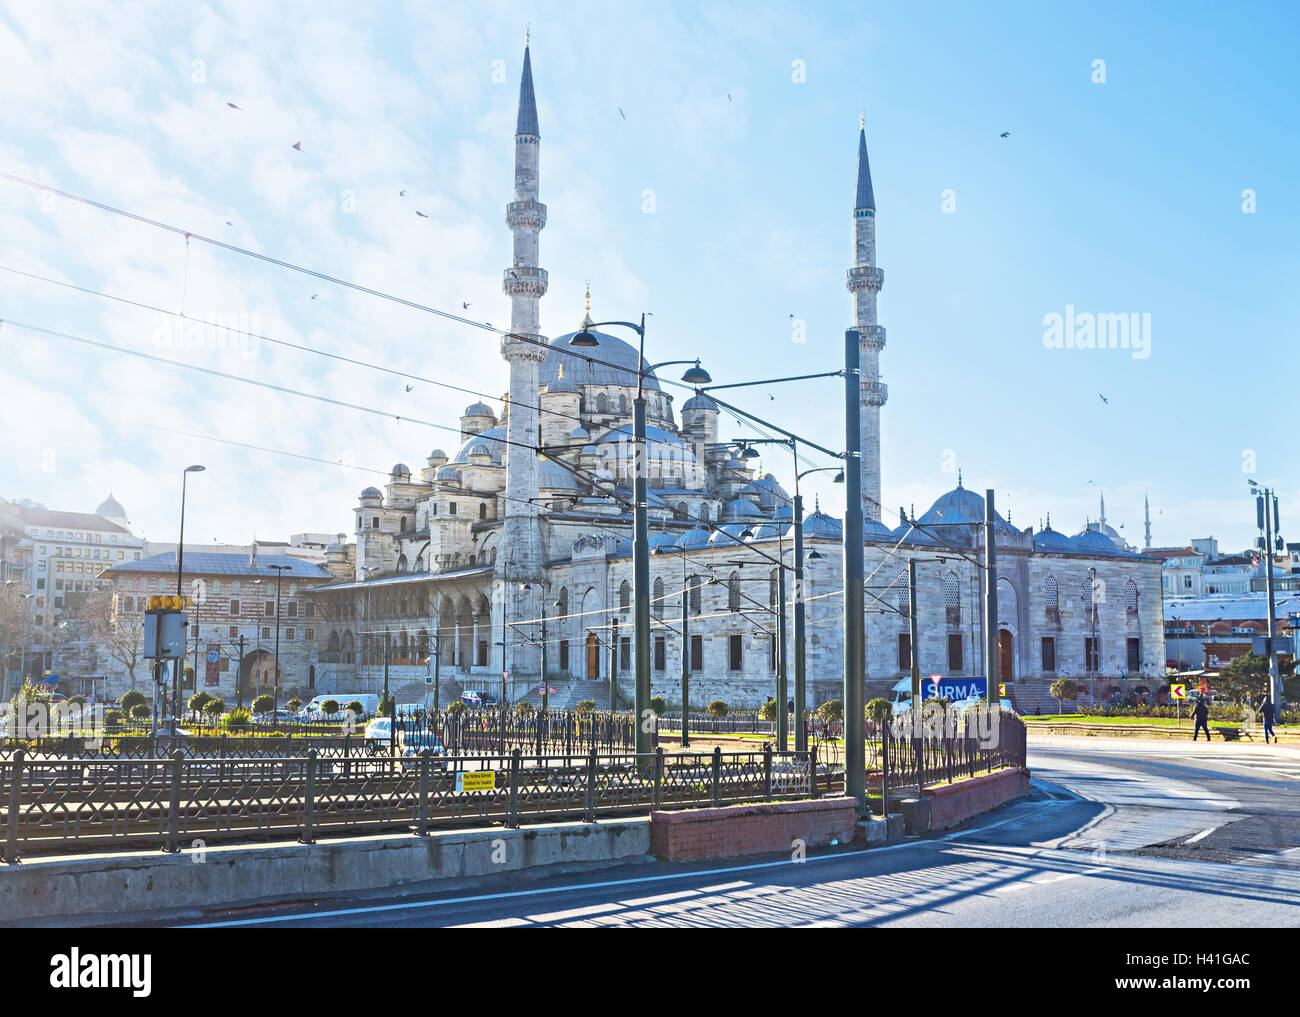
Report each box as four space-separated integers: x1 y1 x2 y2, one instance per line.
569 315 712 756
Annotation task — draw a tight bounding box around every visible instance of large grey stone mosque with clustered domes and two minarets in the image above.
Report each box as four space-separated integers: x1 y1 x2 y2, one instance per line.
306 46 1165 710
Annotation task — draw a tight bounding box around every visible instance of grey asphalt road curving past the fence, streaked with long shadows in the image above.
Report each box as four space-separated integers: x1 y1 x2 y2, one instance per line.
172 743 1300 927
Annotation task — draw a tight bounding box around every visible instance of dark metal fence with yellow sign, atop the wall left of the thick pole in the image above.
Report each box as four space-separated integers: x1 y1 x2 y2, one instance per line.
0 749 833 862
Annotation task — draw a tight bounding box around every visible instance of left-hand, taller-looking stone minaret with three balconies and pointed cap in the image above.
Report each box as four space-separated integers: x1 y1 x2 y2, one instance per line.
497 38 546 674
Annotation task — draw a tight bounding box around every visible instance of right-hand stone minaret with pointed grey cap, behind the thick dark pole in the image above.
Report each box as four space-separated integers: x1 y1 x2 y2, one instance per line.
848 117 889 519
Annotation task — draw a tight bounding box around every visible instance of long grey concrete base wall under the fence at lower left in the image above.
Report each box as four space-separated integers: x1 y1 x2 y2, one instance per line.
0 817 650 923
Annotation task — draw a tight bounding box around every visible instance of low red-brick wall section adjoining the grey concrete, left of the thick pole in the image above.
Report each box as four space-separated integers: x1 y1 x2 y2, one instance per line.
650 797 858 861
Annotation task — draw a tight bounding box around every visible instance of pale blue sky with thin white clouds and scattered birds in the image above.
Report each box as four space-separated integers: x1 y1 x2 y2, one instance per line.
0 0 1300 550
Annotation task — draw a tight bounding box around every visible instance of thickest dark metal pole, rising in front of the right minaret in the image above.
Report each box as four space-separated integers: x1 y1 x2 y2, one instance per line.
844 329 867 815
